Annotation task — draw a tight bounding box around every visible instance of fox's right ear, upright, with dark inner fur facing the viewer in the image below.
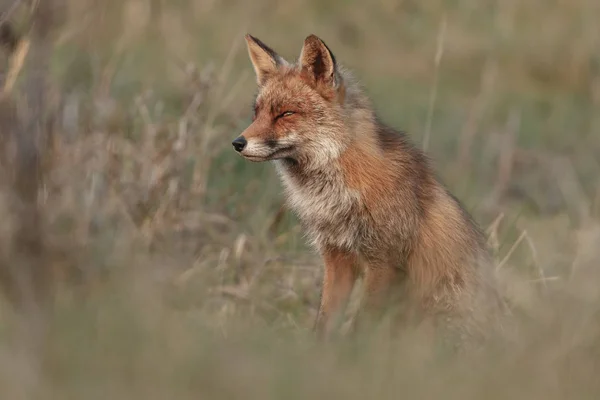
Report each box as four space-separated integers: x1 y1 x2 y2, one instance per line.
300 35 338 86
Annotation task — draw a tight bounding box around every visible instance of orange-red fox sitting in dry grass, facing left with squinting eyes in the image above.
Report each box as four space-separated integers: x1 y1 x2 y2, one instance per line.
232 34 502 348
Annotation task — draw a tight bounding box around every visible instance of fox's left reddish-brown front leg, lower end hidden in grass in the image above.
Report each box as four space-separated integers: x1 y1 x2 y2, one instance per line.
314 249 358 338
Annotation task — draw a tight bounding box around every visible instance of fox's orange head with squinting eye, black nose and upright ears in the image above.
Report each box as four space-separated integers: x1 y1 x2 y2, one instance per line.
232 35 346 162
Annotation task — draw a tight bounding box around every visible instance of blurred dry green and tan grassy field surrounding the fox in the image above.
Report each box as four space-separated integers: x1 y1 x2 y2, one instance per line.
0 0 600 400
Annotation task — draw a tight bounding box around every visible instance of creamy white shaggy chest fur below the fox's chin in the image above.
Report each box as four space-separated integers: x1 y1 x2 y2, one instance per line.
275 161 361 250
